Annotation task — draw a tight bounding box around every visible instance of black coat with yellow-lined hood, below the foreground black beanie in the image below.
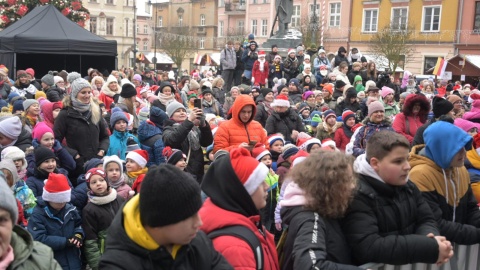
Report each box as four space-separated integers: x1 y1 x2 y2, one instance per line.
99 205 233 270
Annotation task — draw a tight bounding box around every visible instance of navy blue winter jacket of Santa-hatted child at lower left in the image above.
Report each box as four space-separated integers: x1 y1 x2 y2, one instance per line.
28 199 84 270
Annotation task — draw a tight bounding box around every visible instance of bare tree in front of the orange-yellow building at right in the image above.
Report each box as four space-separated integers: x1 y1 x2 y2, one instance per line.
369 25 415 72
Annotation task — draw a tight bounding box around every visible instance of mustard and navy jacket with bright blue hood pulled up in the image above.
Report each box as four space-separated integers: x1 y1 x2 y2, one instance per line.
409 121 480 245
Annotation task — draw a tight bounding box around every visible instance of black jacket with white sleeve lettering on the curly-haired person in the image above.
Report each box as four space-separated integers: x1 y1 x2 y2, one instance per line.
281 206 361 270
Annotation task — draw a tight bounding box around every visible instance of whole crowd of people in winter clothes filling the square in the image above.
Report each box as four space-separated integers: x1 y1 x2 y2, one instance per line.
0 39 480 270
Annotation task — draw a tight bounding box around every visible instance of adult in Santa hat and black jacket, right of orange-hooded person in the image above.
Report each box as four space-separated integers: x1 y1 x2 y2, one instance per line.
265 95 305 143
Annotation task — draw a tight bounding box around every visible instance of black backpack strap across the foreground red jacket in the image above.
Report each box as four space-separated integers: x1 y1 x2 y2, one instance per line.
208 225 263 270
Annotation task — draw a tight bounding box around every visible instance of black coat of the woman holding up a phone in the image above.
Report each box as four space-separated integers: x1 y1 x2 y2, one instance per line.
163 120 213 182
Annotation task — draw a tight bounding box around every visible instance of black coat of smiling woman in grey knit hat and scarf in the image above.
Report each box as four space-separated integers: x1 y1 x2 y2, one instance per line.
53 106 110 161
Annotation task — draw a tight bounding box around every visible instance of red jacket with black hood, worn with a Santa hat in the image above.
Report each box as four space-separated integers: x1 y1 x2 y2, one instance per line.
199 152 279 270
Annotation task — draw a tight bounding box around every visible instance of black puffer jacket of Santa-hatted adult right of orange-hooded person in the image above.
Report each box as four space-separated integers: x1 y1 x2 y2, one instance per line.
265 108 305 142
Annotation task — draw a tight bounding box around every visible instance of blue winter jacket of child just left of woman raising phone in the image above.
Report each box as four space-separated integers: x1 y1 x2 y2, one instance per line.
137 121 165 167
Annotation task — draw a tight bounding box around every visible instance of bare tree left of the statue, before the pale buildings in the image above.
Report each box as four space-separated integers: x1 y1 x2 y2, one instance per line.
158 26 198 70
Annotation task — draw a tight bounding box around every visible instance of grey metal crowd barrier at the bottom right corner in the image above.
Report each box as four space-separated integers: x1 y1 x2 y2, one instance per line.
360 244 480 270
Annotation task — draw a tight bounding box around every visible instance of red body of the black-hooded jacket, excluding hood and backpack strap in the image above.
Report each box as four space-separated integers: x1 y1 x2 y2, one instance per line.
199 198 279 270
